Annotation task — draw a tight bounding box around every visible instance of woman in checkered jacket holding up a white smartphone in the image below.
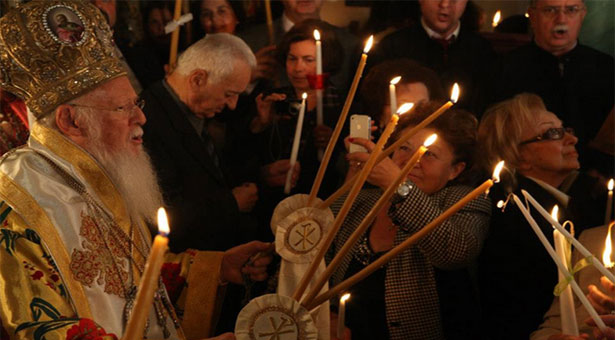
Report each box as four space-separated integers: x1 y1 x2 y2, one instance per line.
328 102 491 340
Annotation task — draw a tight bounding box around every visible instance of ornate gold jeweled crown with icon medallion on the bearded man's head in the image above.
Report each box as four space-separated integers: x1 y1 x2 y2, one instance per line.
0 0 126 119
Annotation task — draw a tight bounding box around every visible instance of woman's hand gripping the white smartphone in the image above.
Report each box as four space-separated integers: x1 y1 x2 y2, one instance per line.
346 138 401 190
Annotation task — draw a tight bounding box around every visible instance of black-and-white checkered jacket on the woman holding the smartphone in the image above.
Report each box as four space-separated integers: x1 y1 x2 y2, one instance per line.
328 185 491 340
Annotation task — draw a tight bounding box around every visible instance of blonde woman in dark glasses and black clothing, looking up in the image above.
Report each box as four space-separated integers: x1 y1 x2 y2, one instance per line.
478 93 606 339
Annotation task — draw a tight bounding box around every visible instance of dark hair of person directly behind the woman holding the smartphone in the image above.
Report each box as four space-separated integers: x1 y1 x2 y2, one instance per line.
360 58 445 120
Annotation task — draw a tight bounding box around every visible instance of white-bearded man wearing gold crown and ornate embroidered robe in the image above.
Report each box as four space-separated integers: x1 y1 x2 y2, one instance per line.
0 1 270 340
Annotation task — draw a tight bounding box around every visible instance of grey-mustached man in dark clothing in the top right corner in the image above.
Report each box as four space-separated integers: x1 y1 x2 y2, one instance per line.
487 0 615 173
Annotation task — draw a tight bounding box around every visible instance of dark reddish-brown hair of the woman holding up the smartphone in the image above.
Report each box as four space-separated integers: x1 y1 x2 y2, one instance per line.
388 101 478 183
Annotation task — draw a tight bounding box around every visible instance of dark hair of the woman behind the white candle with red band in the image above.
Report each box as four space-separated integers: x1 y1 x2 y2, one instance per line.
276 19 344 74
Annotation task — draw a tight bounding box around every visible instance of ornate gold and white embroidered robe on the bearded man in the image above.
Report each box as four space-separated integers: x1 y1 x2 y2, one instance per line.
0 124 223 340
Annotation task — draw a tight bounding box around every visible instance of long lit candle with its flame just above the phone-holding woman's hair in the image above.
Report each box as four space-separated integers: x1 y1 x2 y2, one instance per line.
318 83 460 209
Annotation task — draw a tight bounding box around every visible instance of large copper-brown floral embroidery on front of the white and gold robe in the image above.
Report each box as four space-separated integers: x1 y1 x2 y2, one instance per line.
70 214 130 298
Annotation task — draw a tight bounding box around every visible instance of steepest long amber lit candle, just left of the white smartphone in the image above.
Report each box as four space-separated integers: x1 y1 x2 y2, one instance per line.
308 35 374 206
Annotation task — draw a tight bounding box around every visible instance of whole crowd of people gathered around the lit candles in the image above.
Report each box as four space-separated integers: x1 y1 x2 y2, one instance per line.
0 0 615 340
